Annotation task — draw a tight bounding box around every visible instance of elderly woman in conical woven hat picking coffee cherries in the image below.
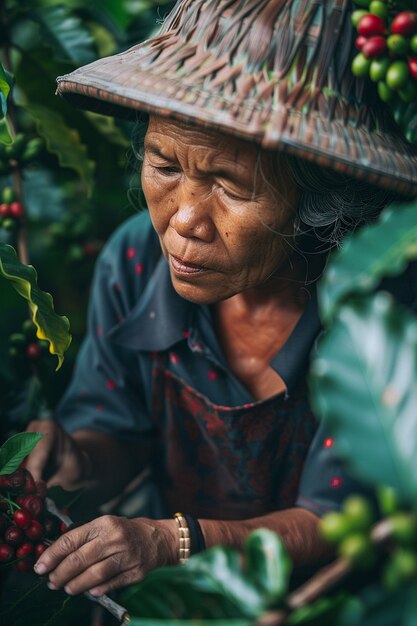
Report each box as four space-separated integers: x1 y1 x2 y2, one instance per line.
28 0 417 595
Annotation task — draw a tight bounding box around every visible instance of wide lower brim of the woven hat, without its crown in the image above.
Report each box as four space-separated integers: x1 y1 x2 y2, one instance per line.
57 52 417 197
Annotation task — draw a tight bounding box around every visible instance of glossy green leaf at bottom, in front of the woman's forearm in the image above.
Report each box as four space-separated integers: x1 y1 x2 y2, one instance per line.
121 529 289 623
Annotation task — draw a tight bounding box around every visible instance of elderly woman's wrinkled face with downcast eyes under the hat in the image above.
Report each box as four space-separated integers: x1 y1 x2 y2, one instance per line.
142 116 296 304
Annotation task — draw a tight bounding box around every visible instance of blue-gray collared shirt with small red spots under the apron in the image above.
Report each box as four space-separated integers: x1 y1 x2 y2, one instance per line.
57 212 384 514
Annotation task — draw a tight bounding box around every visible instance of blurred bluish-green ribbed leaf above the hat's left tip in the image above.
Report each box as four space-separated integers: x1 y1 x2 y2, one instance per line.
31 4 96 65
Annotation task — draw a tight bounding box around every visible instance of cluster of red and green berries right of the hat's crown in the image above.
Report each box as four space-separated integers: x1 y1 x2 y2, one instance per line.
352 0 417 103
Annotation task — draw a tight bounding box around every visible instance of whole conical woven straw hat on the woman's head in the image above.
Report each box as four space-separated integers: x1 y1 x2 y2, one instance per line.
57 0 417 195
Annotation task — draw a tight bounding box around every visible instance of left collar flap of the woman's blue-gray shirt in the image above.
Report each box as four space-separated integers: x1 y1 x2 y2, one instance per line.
109 257 194 352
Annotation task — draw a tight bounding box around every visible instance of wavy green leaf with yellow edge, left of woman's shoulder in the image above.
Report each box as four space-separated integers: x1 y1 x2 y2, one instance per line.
0 242 71 369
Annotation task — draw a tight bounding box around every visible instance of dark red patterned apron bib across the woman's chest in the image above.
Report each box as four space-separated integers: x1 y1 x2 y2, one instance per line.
152 355 317 519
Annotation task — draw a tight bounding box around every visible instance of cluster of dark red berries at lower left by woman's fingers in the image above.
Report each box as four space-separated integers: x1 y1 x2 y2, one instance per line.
0 467 67 572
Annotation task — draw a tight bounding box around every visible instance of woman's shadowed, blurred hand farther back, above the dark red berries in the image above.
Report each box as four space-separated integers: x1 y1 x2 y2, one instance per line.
26 420 90 491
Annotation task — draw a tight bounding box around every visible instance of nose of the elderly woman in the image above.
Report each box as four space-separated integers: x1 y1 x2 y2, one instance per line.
171 179 215 243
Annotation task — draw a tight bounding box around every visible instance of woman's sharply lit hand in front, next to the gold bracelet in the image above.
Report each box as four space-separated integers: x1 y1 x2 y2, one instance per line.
35 515 178 596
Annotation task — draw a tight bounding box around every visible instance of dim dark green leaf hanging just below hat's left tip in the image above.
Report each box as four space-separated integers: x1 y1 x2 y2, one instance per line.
27 104 95 195
